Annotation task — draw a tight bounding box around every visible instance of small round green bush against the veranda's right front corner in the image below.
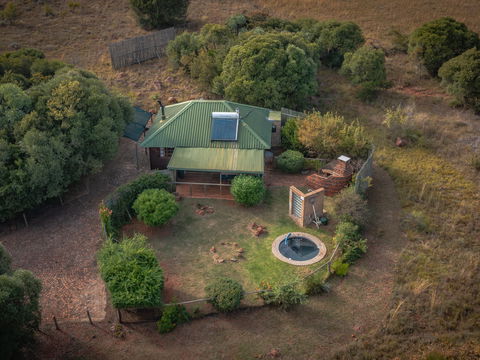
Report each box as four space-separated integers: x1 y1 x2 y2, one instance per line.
230 175 266 206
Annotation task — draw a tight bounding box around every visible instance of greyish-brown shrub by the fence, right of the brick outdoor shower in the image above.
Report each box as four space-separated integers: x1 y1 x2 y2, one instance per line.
332 187 368 227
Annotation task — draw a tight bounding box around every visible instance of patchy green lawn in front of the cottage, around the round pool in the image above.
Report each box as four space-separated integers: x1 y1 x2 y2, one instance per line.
124 187 333 301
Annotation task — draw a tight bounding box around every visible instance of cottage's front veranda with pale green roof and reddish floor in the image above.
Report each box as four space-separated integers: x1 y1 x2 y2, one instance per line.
168 148 264 200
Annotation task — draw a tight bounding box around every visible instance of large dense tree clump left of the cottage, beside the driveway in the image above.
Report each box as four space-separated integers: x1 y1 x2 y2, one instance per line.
0 50 132 221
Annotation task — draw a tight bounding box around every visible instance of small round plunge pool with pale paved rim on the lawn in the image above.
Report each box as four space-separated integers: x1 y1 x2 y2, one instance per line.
272 232 327 265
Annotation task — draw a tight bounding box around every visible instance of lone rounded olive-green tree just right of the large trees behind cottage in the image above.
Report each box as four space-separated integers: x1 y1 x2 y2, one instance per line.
340 46 387 101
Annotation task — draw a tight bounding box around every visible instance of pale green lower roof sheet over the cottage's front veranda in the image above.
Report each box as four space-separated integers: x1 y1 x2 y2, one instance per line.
168 147 264 174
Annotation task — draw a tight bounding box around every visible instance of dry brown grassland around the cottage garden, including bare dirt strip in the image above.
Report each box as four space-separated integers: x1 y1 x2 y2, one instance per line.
0 0 480 360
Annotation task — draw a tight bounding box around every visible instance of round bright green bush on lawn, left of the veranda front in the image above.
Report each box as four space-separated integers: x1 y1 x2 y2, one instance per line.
132 189 178 226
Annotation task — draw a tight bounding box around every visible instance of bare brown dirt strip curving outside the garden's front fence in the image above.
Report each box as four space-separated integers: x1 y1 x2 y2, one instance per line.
31 169 405 359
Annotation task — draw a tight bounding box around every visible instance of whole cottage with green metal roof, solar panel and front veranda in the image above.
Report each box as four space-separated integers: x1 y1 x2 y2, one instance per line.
141 100 280 197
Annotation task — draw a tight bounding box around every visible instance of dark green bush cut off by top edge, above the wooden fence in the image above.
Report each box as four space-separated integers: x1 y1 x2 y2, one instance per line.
130 0 188 30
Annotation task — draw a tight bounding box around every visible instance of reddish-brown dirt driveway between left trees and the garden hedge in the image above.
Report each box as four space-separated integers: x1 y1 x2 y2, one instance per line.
0 139 146 322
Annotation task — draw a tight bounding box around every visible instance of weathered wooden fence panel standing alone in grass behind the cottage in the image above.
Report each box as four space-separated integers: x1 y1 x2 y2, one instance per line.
108 27 175 69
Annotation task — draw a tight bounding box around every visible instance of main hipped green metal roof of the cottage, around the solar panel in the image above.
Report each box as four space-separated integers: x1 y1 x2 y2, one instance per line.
141 100 272 149
